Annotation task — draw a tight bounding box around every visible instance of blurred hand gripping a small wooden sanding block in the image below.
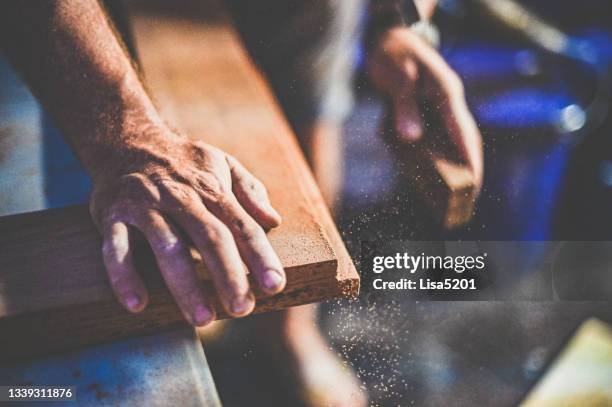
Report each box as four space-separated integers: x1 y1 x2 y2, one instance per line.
368 27 483 190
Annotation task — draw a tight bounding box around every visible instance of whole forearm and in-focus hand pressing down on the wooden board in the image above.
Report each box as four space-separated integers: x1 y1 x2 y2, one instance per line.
0 0 285 325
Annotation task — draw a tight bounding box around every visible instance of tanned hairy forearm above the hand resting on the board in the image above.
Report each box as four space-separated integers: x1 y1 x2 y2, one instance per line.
0 0 162 177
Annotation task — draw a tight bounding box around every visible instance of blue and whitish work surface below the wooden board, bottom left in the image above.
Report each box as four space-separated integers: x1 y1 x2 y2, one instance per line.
0 328 221 407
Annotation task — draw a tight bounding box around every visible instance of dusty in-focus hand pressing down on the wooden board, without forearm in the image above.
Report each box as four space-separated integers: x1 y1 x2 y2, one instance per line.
90 127 285 326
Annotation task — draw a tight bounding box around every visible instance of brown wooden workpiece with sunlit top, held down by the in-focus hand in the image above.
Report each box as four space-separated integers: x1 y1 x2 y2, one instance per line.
0 1 359 359
